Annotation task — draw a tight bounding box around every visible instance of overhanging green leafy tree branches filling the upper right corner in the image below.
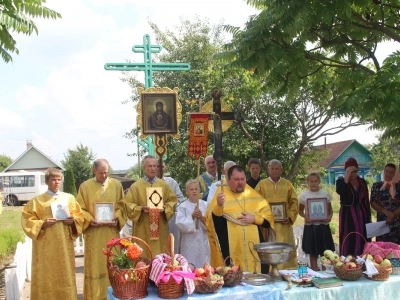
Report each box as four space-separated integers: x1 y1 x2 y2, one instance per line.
219 0 400 136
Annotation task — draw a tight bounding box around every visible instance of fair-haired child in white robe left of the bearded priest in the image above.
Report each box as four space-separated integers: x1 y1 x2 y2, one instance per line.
176 179 210 268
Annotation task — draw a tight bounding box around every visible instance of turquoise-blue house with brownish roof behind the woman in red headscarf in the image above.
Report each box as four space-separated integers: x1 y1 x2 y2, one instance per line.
314 140 380 184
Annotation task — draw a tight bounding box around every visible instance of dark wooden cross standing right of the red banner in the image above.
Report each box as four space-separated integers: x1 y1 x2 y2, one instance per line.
210 88 243 180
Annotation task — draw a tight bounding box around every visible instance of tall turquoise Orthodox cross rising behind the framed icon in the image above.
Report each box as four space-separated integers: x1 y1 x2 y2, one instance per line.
104 34 190 176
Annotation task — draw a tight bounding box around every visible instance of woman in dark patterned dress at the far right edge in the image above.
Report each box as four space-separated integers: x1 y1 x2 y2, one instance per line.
371 163 400 244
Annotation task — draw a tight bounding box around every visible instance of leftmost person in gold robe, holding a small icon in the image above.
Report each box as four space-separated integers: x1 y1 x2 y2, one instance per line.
21 168 83 300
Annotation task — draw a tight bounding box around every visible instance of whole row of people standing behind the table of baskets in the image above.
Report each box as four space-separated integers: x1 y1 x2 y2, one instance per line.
22 155 400 300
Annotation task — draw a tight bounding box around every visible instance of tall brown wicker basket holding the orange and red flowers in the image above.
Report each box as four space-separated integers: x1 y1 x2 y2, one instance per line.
107 236 153 300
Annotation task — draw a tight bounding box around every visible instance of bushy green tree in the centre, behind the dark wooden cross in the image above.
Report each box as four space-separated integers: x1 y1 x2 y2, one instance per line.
120 19 297 184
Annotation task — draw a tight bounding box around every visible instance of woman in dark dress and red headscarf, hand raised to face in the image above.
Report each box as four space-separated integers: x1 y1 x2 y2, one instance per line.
336 157 371 256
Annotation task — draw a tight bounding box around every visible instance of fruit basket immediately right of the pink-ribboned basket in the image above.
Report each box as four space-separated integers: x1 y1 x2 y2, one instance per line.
194 263 224 294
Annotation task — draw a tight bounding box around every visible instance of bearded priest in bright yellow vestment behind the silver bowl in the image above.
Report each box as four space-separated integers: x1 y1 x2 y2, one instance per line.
205 165 274 274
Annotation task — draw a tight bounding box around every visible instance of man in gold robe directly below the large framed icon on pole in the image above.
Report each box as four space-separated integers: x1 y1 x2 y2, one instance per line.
124 155 178 258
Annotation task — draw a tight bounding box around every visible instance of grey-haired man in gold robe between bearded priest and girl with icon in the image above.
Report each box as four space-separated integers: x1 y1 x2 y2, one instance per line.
255 159 299 270
